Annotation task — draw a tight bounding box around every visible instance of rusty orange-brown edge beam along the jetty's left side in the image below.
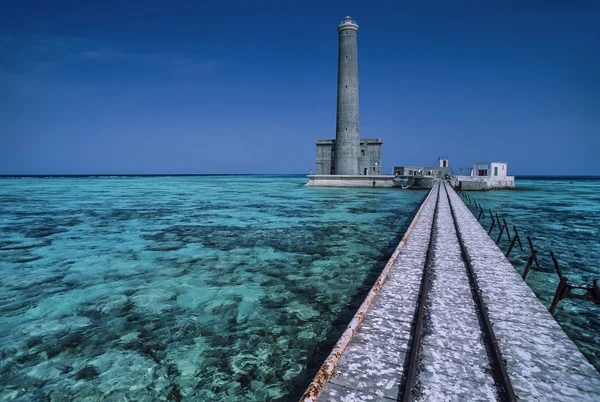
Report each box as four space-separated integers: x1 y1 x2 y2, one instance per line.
299 183 433 402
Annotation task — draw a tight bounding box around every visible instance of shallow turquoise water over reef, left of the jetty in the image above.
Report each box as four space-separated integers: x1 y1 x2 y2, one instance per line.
0 176 425 401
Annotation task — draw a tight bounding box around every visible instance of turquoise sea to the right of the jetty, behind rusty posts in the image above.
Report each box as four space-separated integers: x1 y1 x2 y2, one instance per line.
468 179 600 370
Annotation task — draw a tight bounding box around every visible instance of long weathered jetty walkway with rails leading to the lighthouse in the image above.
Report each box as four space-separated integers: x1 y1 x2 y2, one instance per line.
301 181 600 402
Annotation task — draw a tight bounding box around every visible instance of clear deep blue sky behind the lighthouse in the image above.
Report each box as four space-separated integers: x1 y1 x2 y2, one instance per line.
0 0 600 175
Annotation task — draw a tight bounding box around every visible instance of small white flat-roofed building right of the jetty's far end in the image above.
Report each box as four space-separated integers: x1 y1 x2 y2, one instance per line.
456 162 515 190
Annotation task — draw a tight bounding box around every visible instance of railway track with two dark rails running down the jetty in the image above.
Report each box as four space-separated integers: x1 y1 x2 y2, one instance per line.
399 182 517 402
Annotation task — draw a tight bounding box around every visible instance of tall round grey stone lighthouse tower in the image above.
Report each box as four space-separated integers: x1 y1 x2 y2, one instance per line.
334 17 360 175
